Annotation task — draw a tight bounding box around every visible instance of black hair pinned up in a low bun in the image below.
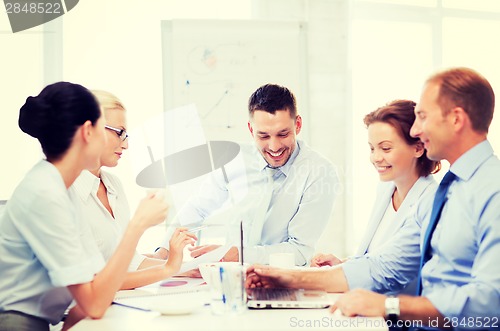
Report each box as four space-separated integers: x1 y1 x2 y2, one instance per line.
19 82 101 161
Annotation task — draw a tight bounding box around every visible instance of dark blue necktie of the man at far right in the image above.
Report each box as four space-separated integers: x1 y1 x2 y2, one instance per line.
416 171 457 295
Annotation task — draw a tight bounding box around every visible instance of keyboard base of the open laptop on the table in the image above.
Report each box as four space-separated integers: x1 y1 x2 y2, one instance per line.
247 287 333 309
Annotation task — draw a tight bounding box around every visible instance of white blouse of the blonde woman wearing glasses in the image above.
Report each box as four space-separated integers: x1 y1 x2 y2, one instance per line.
69 170 146 271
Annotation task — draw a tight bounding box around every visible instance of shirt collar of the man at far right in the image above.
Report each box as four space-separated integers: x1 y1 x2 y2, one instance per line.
450 140 493 181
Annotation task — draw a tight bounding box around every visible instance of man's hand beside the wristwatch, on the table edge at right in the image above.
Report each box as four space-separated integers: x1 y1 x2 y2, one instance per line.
330 289 387 317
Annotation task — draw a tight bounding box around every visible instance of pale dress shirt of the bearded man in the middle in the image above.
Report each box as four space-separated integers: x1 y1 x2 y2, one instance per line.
163 141 340 265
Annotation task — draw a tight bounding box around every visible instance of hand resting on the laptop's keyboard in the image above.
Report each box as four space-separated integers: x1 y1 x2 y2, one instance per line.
245 265 297 288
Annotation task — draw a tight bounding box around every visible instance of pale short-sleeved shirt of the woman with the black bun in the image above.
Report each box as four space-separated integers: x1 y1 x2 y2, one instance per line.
0 161 104 324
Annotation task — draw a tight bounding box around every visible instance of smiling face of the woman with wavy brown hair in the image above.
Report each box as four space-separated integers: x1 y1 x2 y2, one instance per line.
368 122 423 182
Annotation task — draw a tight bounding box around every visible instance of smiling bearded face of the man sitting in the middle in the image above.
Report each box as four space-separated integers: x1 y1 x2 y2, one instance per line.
248 110 302 168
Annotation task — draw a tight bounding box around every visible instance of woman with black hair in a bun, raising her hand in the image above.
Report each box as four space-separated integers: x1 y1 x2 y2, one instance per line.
0 82 172 331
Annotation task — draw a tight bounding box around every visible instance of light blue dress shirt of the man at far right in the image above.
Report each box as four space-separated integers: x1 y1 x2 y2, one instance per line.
422 141 500 318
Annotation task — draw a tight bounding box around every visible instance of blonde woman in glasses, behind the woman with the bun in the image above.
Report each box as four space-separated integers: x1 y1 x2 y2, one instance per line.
70 90 196 289
